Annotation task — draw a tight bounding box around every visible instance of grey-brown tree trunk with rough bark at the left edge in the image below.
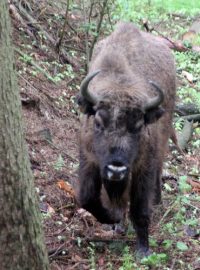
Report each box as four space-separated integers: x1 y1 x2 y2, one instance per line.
0 0 49 270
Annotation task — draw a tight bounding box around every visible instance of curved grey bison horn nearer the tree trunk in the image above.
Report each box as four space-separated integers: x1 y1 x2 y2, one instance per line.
80 70 100 104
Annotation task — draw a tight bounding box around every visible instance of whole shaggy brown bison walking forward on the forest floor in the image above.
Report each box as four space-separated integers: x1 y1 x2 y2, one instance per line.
78 23 176 255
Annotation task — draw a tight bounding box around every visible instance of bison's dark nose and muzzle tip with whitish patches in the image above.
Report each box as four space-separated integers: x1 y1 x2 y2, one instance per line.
106 163 128 181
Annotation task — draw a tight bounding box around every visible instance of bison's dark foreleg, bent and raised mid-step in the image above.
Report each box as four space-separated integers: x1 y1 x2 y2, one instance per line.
78 163 116 224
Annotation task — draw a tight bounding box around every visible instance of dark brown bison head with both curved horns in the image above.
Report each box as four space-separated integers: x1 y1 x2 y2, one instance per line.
81 71 164 182
